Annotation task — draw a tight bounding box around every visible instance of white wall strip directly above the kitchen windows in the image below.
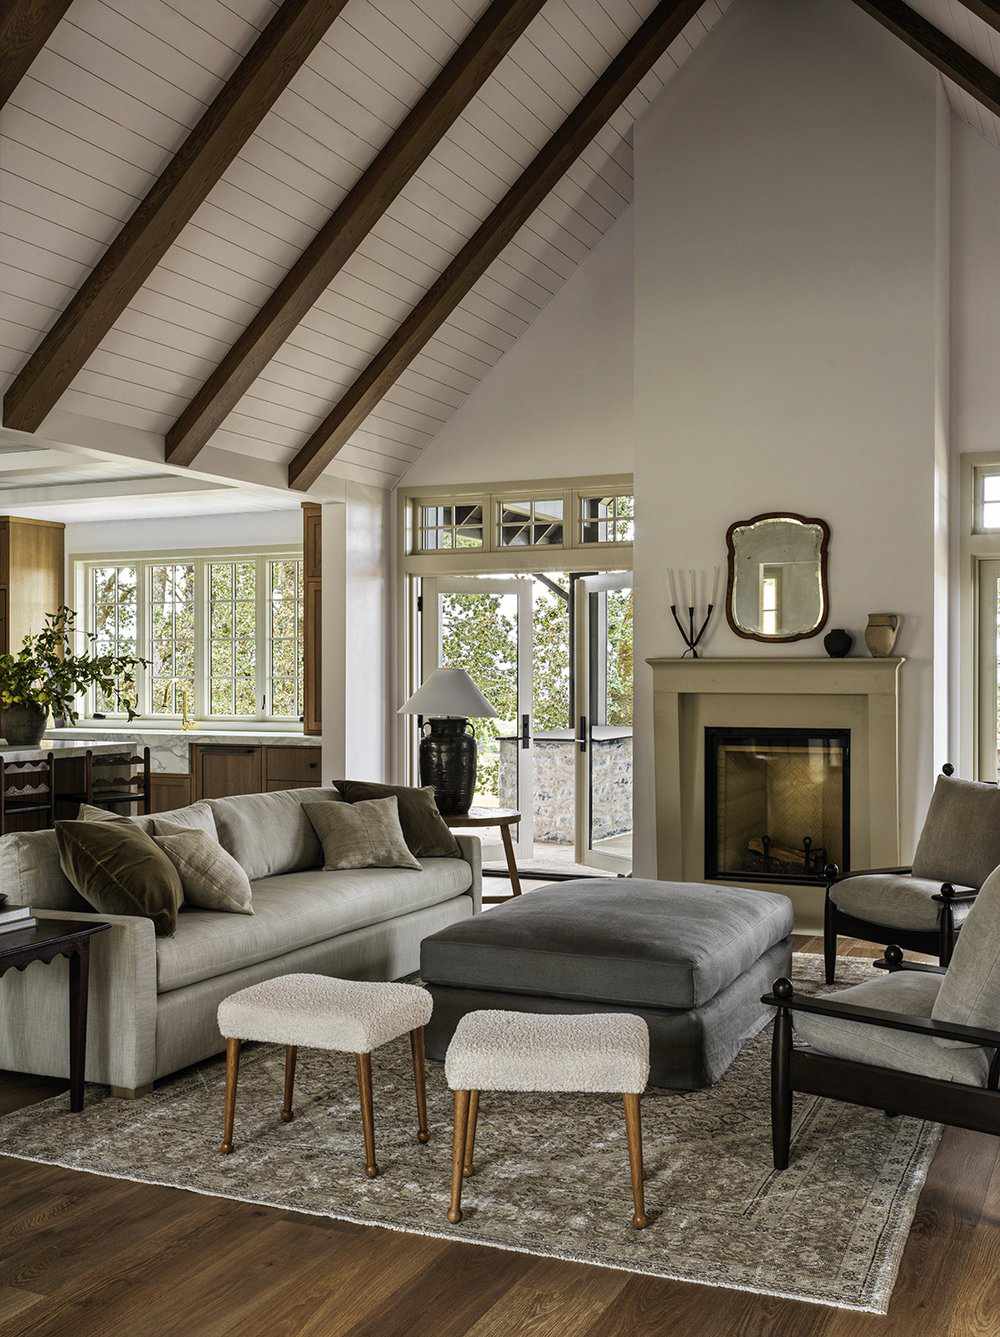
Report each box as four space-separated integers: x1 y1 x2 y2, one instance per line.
66 507 302 556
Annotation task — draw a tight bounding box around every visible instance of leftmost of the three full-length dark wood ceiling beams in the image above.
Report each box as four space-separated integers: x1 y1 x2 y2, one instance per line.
4 0 346 432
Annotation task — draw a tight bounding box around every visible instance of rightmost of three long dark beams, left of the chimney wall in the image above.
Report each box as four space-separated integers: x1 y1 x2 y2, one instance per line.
289 0 702 489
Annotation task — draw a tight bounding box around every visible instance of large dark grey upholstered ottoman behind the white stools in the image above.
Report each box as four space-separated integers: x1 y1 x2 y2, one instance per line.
420 878 791 1090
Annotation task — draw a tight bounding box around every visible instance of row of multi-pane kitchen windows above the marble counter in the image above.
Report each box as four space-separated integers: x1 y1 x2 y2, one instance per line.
83 554 303 721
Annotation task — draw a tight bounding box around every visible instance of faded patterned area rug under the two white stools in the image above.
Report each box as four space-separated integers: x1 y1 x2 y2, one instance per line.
0 955 940 1313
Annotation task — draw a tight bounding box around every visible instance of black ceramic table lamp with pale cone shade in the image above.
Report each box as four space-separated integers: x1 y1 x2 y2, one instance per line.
398 669 496 817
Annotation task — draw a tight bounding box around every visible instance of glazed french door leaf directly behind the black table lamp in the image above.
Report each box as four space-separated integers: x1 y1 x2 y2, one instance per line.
421 576 535 862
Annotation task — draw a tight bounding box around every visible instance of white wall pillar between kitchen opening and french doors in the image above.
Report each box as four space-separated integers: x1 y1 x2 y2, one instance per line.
322 483 392 781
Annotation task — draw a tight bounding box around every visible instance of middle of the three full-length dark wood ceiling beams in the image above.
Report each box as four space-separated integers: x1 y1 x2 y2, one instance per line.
167 0 544 464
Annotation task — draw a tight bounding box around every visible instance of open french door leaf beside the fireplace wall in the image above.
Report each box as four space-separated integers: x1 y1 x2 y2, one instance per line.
574 571 632 873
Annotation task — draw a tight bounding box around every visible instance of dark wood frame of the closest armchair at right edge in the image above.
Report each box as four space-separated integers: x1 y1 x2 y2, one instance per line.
762 944 1000 1170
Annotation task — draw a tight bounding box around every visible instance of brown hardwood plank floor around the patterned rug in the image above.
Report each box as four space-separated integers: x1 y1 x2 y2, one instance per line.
0 940 1000 1337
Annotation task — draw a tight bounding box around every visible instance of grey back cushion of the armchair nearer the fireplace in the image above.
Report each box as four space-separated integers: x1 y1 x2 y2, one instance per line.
913 775 1000 886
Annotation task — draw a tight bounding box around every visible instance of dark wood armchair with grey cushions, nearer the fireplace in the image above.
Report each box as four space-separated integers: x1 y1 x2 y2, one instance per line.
824 765 1000 984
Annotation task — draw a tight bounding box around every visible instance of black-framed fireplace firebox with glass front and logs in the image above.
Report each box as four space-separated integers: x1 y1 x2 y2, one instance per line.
705 729 850 885
